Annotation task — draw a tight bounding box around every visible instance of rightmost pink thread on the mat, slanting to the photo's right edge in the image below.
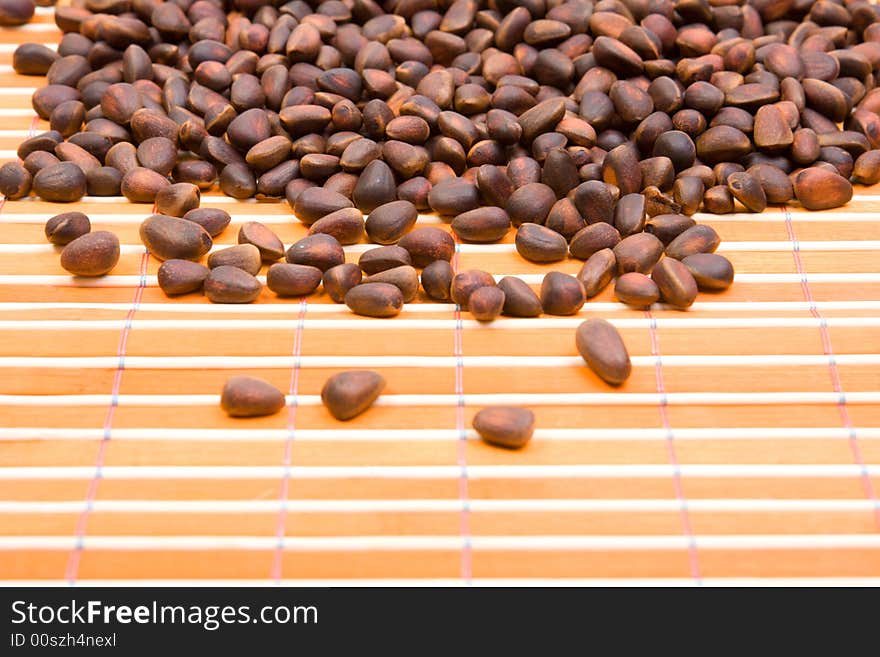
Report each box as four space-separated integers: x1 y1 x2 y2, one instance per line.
782 205 880 529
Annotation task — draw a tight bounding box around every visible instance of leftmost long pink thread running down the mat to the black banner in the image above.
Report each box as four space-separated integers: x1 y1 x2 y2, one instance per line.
64 251 150 586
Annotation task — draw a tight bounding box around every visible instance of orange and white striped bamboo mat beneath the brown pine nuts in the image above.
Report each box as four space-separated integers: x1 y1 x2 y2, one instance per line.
0 10 880 585
